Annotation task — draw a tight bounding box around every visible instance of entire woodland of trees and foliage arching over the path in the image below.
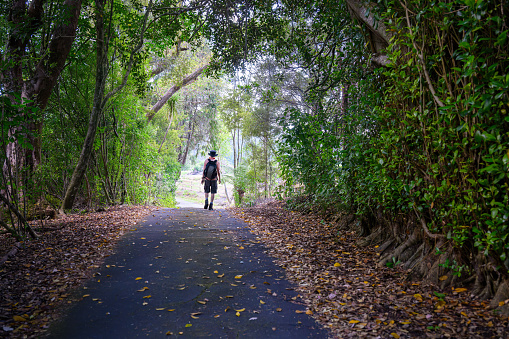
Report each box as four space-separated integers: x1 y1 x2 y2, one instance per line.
0 0 509 310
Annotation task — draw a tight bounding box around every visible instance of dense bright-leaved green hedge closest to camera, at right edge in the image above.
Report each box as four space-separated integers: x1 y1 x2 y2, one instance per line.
376 1 509 269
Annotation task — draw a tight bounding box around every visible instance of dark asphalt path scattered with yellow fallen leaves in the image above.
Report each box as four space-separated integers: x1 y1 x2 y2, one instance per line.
50 208 328 339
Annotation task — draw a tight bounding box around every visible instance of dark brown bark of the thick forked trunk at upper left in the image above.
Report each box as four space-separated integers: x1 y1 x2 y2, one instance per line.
1 0 82 170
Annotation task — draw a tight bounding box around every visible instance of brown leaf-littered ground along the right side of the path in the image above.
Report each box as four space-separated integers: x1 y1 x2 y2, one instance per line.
229 203 509 338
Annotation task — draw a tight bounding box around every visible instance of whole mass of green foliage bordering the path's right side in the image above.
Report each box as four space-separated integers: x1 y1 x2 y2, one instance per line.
279 0 509 272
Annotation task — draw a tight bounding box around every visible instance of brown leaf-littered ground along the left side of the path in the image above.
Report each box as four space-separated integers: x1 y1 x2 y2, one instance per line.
0 206 154 338
